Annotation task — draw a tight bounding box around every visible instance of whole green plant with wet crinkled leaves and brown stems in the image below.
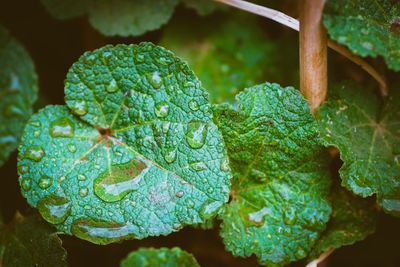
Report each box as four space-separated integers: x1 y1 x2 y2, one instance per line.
0 0 400 267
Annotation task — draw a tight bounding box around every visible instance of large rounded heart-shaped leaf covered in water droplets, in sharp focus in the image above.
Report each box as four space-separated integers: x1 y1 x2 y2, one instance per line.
18 43 231 244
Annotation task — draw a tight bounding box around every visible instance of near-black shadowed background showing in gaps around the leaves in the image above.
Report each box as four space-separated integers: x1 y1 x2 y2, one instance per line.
0 0 400 267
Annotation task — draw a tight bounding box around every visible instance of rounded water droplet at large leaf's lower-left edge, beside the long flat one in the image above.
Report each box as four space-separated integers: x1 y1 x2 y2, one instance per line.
38 196 71 224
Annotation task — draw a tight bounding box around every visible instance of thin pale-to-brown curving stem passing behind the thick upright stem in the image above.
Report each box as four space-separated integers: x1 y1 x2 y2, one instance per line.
214 0 388 95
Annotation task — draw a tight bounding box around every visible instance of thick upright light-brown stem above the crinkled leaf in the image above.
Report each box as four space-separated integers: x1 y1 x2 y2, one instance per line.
300 0 328 113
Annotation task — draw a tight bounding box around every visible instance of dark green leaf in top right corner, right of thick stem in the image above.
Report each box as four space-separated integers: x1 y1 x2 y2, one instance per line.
324 0 400 71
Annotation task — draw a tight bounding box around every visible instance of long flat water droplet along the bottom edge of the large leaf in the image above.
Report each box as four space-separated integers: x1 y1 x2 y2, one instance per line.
71 219 139 245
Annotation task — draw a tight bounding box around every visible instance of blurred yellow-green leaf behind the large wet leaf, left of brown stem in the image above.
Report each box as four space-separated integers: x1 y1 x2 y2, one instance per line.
160 14 298 103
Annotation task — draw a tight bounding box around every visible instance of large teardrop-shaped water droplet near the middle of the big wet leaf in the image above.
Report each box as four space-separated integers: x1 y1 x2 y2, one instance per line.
94 158 149 202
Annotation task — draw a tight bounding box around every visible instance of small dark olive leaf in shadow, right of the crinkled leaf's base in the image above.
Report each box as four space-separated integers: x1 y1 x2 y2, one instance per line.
310 186 378 259
